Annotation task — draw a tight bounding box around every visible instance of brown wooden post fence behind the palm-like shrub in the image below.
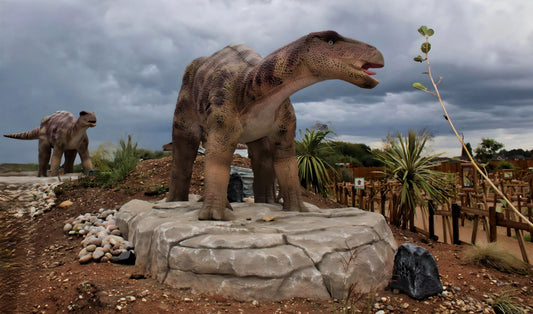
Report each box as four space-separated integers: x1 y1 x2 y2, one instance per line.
334 174 533 263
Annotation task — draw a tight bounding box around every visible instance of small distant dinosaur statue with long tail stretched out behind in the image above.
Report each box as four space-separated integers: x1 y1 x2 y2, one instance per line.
4 111 96 177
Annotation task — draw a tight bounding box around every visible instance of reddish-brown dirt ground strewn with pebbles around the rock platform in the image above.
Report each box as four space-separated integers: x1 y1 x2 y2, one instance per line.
0 155 533 313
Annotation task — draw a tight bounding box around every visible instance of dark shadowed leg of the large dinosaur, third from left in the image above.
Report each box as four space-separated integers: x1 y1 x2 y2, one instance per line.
247 137 276 204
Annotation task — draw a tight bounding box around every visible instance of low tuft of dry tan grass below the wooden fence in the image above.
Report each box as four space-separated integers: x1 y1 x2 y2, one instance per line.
466 243 531 275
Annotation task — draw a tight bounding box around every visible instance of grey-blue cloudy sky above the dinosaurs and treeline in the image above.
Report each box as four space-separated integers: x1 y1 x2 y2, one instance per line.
0 0 533 163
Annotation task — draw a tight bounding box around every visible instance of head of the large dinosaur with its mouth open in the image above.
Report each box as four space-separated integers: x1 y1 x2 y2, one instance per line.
302 31 384 88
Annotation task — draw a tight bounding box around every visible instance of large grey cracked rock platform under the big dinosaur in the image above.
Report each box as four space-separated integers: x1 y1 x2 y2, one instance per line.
116 200 397 301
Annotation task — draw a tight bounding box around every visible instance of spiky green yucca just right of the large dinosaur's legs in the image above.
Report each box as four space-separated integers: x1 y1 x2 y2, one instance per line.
296 129 334 196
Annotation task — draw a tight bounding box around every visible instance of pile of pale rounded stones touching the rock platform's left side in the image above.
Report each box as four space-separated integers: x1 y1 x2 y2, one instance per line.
63 208 135 264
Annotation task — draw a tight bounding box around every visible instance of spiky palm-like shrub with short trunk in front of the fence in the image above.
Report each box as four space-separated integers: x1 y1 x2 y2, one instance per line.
376 130 451 229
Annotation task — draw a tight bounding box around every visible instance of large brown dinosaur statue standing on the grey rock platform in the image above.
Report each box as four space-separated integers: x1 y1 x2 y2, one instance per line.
167 31 384 220
